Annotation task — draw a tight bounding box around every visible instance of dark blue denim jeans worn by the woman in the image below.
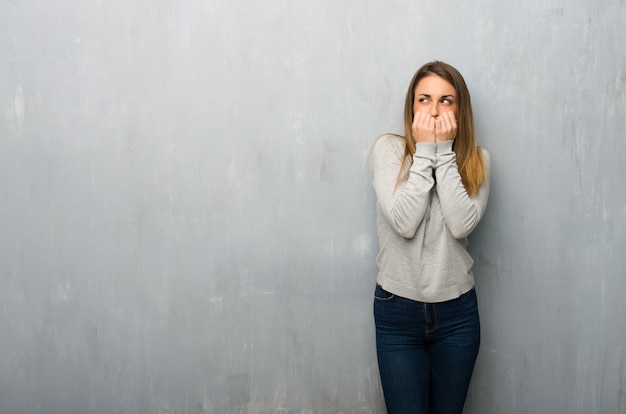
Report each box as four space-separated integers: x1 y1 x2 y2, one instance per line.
374 285 480 414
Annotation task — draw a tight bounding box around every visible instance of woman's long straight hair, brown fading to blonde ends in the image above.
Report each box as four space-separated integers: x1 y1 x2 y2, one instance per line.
397 61 485 196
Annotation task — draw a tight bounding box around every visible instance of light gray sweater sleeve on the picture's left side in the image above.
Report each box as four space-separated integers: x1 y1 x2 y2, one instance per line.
373 136 436 239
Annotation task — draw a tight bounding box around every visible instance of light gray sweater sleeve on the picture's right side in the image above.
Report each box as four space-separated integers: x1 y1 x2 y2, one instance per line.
435 141 491 239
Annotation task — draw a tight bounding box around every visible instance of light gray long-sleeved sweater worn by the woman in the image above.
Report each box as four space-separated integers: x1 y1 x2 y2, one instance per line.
371 135 491 303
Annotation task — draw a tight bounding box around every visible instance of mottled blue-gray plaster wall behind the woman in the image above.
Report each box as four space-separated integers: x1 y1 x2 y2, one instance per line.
0 0 626 414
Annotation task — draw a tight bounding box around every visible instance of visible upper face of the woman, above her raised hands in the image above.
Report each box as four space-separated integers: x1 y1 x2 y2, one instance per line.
413 75 457 118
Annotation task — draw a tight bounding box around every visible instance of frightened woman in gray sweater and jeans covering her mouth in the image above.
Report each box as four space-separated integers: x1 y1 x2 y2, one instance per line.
372 61 490 414
